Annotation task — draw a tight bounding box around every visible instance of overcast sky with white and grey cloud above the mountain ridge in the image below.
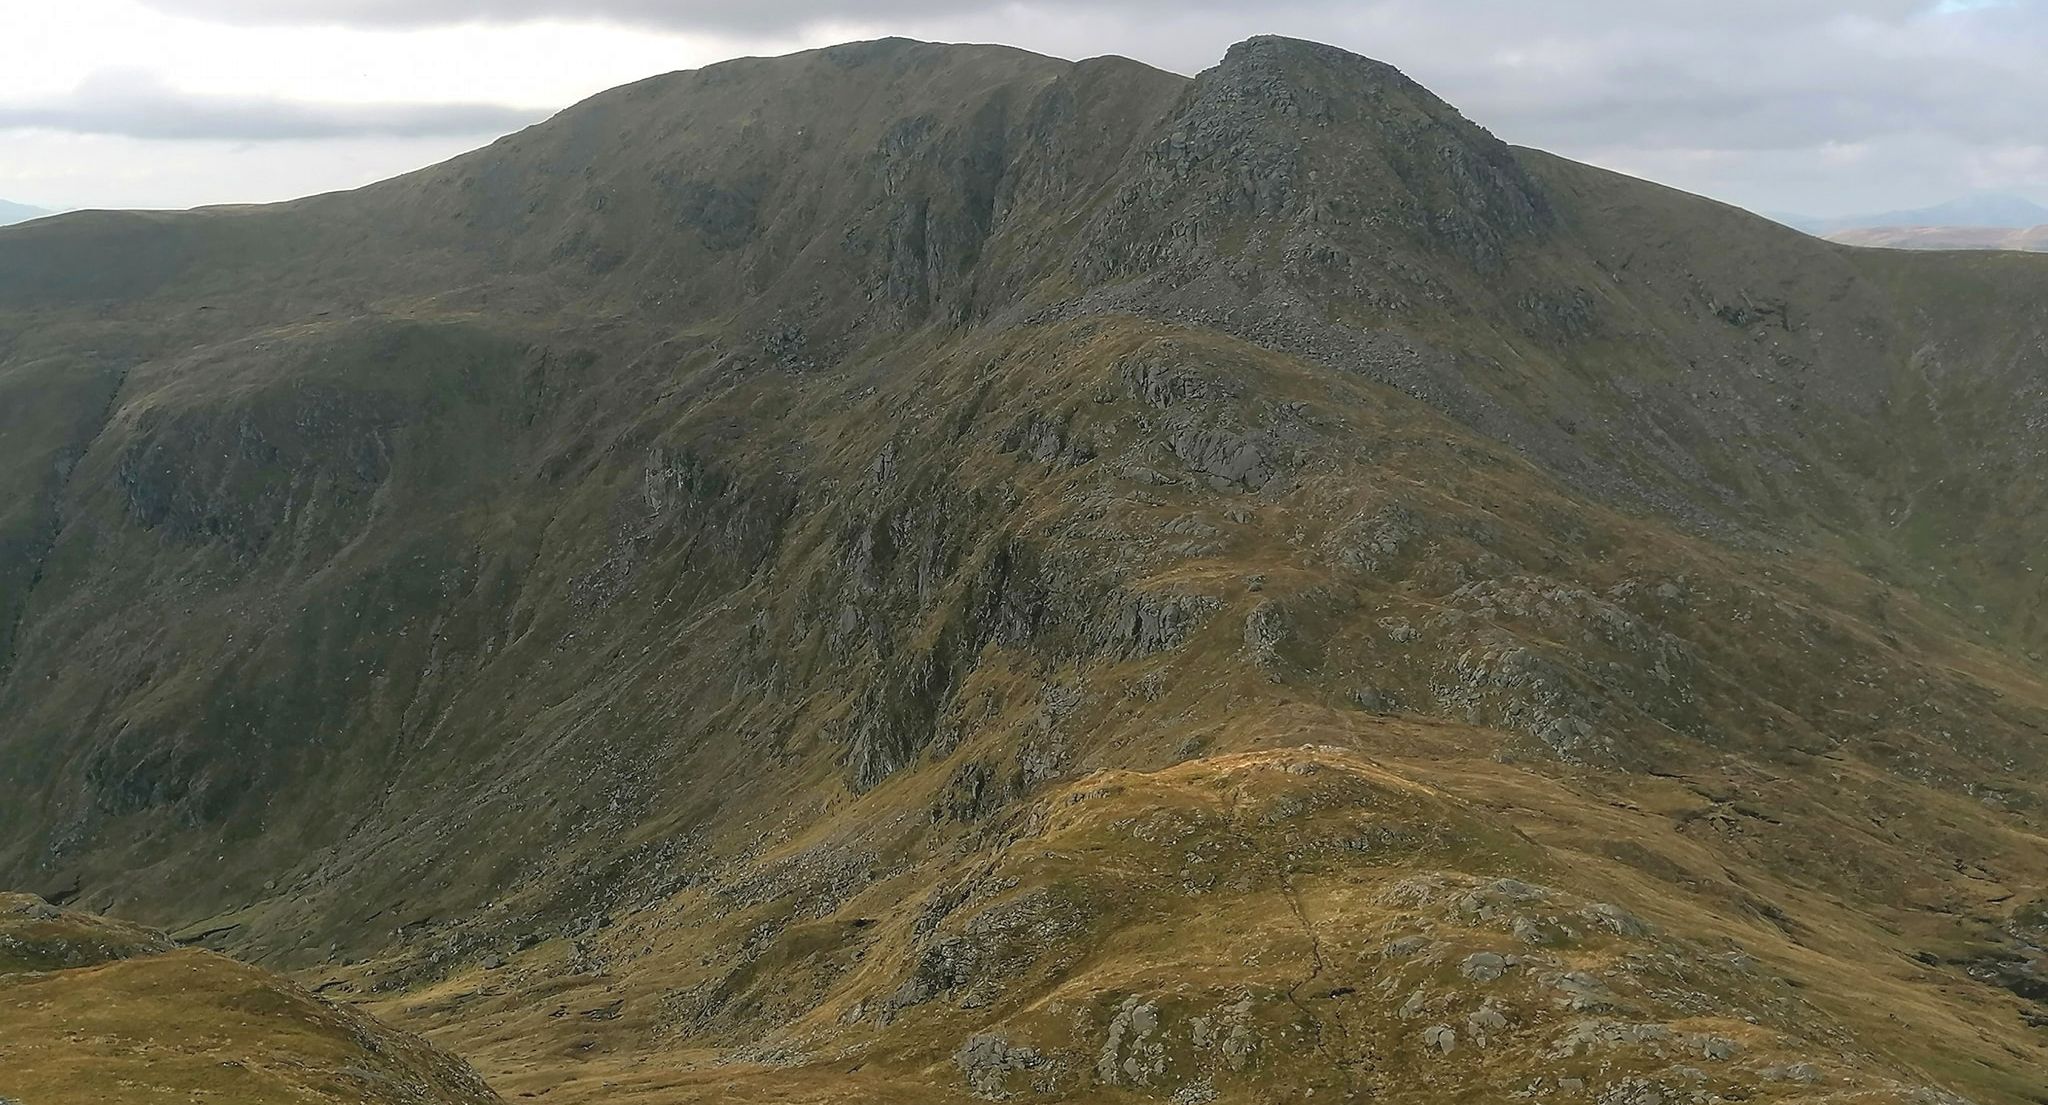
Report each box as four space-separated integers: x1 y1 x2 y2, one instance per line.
0 0 2048 215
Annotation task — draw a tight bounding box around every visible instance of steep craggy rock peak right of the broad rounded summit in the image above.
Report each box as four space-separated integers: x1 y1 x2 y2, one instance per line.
1085 37 1554 292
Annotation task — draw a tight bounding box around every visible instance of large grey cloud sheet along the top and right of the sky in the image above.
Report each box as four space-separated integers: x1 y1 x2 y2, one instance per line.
123 0 2048 207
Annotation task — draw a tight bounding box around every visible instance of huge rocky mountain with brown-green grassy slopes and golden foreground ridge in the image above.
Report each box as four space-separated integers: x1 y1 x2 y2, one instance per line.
0 39 2048 1105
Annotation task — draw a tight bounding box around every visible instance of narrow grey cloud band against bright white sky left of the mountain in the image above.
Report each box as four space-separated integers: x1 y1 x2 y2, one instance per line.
0 74 545 141
